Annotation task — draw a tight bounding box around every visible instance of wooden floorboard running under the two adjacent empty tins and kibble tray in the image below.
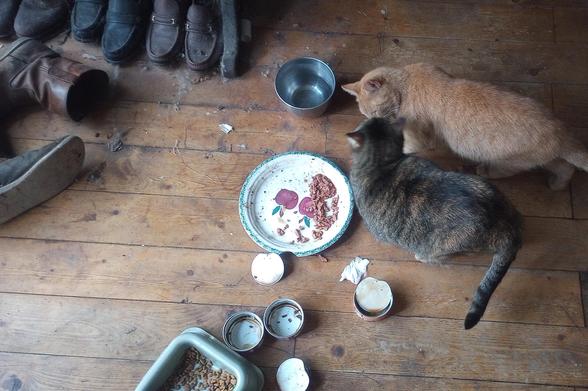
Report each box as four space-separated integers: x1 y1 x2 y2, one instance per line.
0 294 588 385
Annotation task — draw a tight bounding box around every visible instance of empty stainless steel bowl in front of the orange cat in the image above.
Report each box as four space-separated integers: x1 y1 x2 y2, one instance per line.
274 57 336 118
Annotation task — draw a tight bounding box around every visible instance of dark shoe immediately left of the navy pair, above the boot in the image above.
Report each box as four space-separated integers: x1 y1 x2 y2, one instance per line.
14 0 71 41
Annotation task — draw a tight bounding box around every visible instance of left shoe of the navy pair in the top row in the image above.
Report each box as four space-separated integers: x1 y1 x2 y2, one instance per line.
71 0 108 42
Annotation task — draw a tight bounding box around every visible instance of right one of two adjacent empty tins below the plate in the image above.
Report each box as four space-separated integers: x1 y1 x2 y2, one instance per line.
263 299 304 339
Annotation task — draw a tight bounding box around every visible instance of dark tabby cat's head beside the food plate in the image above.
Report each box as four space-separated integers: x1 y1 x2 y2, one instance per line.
347 118 405 164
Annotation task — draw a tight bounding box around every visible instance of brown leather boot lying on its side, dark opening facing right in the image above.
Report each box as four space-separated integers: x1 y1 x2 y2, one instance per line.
0 38 108 121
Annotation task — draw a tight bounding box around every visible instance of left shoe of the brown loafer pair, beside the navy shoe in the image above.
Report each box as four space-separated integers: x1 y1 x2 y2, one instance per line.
146 0 188 64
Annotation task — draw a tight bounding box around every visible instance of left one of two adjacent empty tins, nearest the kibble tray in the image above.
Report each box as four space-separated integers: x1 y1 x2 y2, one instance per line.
223 311 265 352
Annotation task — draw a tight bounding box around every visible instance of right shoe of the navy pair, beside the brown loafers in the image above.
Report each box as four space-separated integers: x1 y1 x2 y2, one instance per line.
102 0 152 64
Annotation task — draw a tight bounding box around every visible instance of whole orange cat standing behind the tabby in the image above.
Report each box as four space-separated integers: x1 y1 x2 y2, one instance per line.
343 64 588 190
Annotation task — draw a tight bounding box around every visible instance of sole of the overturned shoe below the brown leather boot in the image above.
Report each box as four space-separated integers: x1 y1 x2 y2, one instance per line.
0 136 85 224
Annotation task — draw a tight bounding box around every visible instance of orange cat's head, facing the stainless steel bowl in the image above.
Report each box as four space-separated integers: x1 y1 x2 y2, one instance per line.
341 68 401 119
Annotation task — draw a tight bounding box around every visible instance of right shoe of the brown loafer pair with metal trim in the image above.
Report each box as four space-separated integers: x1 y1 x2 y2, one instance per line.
185 4 222 71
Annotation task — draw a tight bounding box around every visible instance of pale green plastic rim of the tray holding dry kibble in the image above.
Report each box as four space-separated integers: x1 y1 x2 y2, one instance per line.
135 327 263 391
